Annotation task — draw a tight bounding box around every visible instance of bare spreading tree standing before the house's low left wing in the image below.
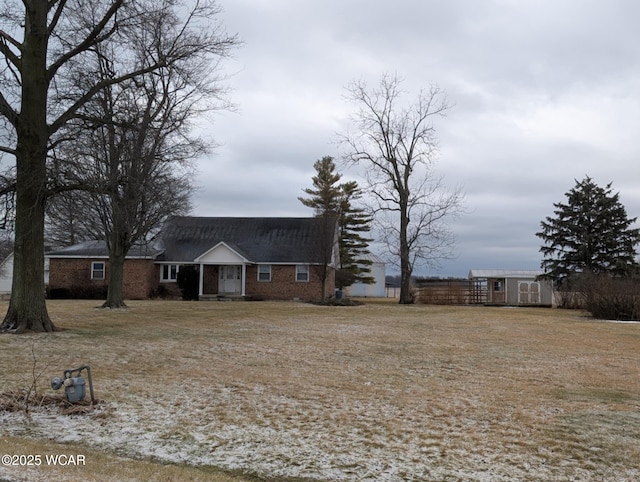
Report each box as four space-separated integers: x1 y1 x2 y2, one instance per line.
50 9 228 308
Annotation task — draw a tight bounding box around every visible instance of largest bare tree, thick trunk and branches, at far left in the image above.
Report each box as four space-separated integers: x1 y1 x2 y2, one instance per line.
0 0 237 333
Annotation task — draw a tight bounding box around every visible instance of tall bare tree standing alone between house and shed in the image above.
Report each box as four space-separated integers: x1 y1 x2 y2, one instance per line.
341 75 463 303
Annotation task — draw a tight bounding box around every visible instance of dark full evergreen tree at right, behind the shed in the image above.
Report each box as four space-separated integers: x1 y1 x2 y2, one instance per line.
536 176 640 287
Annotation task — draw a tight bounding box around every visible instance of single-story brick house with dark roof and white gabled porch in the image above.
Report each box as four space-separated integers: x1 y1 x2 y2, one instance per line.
48 216 338 299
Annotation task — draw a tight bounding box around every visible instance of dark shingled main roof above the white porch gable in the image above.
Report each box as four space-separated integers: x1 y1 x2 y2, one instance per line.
157 216 335 263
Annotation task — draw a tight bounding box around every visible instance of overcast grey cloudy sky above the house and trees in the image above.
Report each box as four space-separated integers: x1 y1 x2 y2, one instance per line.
193 0 640 277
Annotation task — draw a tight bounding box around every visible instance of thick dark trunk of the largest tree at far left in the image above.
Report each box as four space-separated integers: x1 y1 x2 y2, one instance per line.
2 0 55 333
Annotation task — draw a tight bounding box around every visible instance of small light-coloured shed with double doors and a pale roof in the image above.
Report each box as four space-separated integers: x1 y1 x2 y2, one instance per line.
469 269 553 306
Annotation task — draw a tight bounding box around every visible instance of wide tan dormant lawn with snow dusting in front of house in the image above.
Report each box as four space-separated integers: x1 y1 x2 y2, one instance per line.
0 301 640 482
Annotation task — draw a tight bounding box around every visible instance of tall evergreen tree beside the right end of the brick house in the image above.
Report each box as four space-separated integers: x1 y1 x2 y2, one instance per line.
298 156 374 288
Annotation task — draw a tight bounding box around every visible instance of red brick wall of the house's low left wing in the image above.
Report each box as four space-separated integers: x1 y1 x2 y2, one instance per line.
49 258 160 299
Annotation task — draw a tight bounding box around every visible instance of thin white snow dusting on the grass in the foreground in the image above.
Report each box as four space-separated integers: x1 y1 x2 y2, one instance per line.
0 384 640 482
